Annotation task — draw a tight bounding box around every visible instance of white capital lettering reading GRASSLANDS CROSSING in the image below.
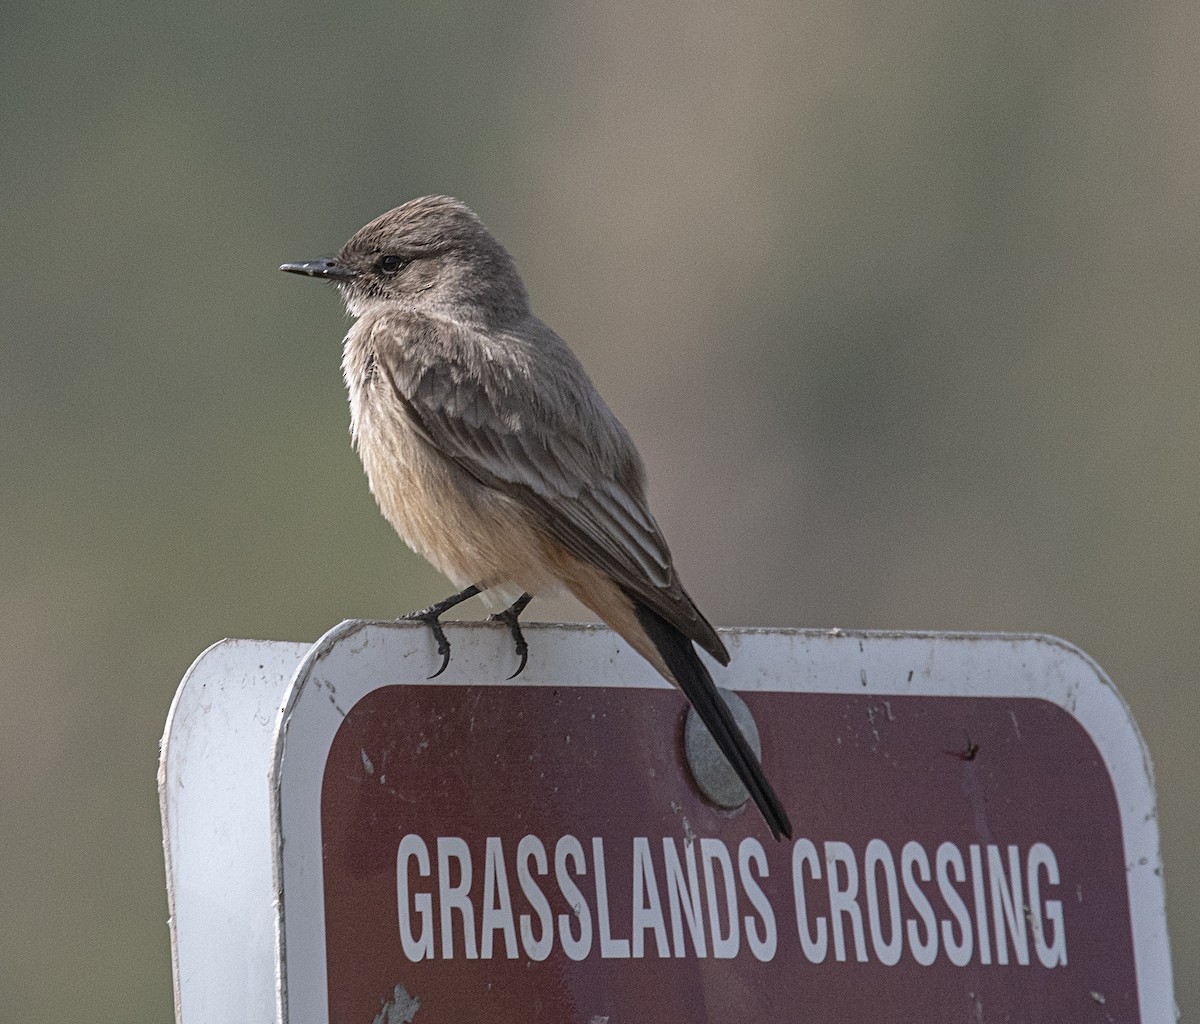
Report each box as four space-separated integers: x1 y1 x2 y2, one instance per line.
396 833 1067 968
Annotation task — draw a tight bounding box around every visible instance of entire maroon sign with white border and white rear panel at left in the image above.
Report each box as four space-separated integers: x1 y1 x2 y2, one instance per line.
160 622 1175 1024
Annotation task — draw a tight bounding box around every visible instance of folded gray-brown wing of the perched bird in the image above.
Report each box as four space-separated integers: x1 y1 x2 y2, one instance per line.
376 318 728 664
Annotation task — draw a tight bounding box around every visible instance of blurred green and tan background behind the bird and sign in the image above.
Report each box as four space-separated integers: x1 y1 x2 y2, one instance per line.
0 0 1200 1022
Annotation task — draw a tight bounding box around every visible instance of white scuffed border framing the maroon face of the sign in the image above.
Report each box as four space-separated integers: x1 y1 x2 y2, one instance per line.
270 619 1178 1024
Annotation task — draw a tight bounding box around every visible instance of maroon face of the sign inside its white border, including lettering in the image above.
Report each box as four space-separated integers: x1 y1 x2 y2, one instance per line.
320 685 1139 1024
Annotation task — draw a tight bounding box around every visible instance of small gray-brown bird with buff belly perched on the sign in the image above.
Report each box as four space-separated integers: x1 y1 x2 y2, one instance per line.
280 196 792 839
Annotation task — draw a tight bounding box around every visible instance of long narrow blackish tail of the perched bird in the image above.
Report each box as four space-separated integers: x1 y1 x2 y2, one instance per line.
632 598 792 839
